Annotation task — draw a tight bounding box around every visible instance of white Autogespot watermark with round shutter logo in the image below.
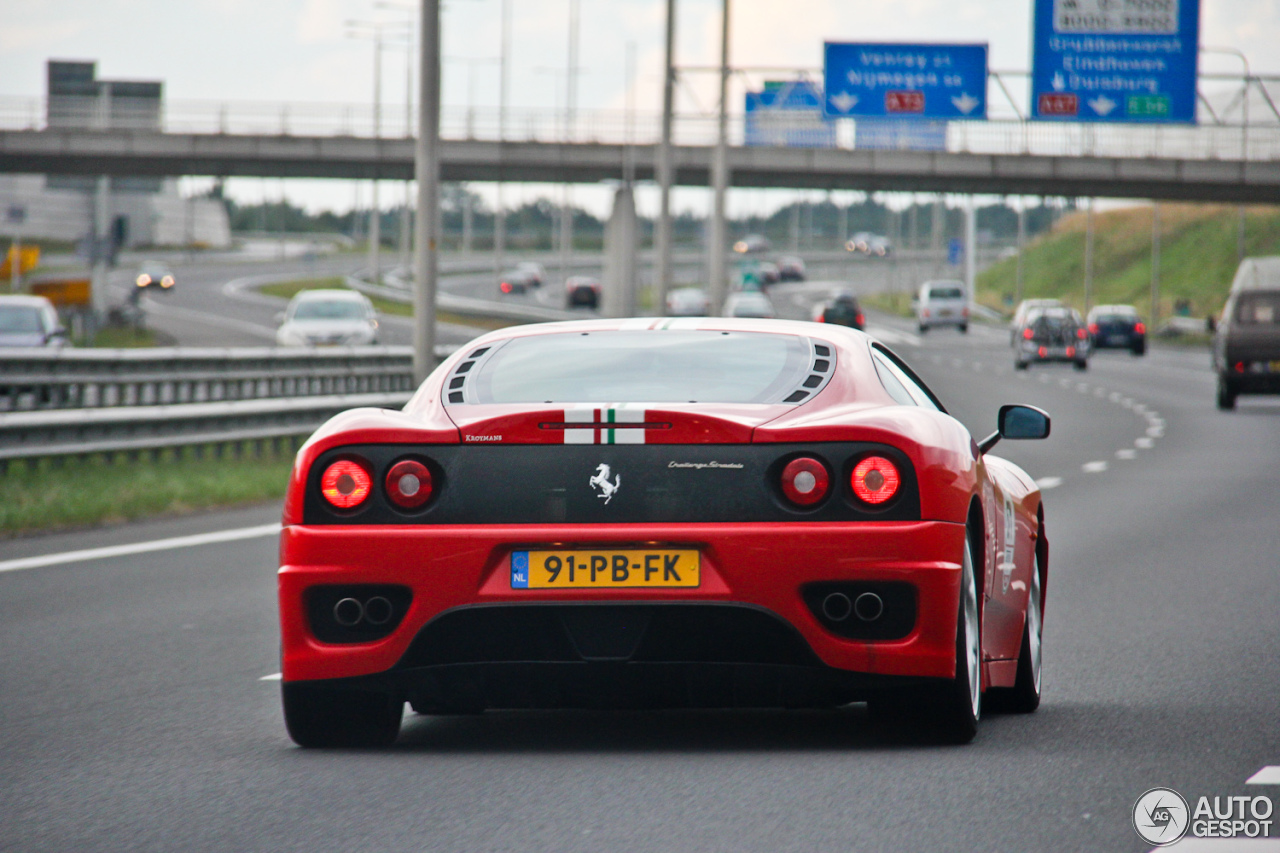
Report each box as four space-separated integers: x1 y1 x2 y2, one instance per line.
1133 788 1275 847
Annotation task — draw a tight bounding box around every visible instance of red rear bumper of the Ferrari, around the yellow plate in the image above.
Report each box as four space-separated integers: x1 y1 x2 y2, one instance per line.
279 521 964 691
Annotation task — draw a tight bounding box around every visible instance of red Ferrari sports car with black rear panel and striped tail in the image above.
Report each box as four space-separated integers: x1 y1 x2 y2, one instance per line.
279 318 1050 747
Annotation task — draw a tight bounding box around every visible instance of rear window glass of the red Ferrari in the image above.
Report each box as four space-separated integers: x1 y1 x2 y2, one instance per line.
467 329 814 403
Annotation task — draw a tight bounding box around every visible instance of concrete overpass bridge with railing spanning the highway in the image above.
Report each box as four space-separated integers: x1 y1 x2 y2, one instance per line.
0 99 1280 204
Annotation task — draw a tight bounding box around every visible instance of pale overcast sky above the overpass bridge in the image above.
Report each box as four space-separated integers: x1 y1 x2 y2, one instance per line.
0 0 1280 212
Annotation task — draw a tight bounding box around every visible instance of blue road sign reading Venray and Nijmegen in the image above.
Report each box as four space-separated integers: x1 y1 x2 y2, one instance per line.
823 41 987 119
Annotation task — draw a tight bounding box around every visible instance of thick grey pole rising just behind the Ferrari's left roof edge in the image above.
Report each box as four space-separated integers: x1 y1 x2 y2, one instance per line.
413 0 440 382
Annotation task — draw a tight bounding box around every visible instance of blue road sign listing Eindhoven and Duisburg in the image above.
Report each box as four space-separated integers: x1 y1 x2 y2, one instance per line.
1032 0 1199 123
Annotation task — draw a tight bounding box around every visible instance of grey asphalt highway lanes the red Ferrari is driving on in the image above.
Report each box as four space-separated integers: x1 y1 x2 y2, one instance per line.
0 277 1280 853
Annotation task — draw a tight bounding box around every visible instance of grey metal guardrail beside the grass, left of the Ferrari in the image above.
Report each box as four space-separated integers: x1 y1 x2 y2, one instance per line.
0 347 415 471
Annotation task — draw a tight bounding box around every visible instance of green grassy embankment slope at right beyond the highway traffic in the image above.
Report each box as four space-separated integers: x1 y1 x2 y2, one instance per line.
977 204 1280 318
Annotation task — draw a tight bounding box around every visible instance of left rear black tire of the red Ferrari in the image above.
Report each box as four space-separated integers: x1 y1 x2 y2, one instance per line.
282 683 404 749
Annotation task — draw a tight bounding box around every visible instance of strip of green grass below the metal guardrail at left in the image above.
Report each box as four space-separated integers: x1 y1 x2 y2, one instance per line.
0 447 293 538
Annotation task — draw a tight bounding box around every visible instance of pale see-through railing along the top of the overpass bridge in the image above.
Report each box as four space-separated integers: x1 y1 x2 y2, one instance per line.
0 78 1280 161
